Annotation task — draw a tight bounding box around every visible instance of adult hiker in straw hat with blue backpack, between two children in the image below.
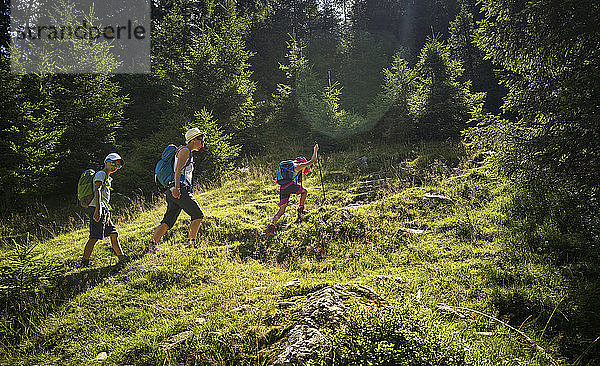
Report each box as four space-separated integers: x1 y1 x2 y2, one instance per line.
146 128 204 253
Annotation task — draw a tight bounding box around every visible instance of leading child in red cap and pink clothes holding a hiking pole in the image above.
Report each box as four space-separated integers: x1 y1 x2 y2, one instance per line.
265 144 319 235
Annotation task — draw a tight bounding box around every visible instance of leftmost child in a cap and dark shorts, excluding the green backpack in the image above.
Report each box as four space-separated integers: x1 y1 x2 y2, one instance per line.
79 153 127 268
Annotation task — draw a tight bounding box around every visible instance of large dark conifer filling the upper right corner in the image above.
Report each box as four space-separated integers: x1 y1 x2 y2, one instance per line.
472 0 600 188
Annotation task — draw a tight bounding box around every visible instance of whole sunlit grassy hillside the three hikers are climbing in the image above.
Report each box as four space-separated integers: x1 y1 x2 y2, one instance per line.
0 142 600 365
